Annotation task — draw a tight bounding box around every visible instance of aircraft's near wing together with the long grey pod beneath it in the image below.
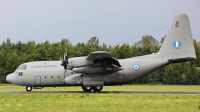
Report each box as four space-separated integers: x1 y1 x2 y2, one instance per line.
73 51 123 74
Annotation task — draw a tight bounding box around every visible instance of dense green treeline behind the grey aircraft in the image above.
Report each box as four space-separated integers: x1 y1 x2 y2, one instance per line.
0 35 200 84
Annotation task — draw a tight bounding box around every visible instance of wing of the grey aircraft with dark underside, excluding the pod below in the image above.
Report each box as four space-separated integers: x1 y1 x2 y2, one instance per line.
86 51 121 67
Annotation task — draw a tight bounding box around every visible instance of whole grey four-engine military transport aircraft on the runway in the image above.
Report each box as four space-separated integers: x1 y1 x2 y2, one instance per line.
6 13 196 92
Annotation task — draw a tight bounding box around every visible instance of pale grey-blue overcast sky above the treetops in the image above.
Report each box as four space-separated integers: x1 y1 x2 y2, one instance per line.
0 0 200 45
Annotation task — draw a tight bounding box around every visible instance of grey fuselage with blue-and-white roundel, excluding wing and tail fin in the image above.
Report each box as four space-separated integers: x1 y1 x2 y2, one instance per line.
13 54 170 87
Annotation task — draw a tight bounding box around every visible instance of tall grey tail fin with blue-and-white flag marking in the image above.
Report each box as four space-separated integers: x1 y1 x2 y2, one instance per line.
158 13 196 62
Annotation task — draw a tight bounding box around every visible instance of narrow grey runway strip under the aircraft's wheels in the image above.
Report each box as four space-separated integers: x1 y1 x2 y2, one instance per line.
0 90 200 95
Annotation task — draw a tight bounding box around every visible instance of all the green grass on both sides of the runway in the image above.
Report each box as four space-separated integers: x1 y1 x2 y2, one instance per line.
0 85 200 112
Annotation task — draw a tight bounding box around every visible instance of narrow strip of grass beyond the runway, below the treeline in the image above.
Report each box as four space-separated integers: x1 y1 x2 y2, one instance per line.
0 84 200 91
